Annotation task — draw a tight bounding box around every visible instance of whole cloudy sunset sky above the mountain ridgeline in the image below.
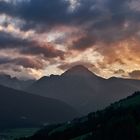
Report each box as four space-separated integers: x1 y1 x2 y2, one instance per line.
0 0 140 79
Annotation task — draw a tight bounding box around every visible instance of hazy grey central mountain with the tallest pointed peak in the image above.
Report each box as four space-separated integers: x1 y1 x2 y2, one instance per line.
26 65 140 114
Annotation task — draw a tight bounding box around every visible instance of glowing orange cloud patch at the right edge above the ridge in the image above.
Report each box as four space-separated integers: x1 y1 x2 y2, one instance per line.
97 37 140 67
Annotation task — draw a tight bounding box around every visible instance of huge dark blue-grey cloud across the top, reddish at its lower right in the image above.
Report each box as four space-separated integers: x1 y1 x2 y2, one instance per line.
0 0 140 49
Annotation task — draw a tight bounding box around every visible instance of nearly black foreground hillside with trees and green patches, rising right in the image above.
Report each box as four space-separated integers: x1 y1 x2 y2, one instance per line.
22 92 140 140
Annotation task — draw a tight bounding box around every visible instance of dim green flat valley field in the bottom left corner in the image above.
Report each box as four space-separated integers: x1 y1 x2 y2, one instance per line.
0 128 40 140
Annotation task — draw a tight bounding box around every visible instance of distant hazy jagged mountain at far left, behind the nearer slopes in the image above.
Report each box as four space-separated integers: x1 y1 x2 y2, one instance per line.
0 74 35 90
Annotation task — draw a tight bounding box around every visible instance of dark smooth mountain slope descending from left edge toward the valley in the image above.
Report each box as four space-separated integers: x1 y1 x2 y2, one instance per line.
0 86 79 129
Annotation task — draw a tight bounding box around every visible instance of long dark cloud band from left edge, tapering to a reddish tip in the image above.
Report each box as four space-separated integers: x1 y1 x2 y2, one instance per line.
0 32 64 59
